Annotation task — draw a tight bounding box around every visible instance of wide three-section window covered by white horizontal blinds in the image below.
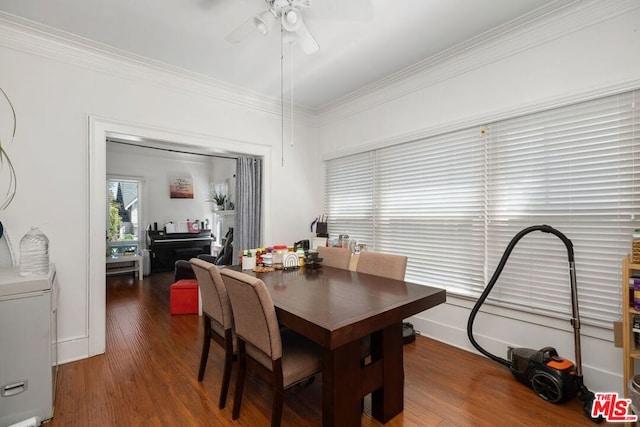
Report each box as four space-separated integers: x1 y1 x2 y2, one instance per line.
325 88 640 327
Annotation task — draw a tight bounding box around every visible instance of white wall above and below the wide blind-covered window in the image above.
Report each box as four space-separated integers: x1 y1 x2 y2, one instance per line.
318 1 640 392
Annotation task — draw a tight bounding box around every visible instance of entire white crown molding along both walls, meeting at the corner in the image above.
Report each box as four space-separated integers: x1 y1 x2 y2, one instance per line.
0 0 640 131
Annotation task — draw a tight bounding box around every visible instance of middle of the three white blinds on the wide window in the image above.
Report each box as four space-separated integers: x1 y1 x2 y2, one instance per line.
374 129 485 293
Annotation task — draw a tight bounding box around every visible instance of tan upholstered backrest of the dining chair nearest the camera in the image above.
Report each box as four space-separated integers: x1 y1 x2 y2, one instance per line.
221 268 282 362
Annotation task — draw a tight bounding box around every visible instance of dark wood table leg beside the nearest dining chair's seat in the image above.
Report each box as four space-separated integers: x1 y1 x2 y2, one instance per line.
322 340 362 427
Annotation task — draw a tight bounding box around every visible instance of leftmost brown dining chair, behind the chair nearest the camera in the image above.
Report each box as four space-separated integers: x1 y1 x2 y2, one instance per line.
190 258 237 409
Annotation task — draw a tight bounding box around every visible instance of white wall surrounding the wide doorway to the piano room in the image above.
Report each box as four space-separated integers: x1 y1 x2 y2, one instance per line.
0 16 320 362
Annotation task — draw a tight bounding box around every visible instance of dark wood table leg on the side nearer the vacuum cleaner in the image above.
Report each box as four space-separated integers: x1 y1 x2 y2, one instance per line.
371 322 404 423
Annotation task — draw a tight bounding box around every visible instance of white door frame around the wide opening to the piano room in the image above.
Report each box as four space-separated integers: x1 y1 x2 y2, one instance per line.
86 116 271 356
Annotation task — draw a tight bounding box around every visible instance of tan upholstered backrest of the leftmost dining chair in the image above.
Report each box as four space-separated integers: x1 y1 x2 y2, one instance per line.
189 258 233 329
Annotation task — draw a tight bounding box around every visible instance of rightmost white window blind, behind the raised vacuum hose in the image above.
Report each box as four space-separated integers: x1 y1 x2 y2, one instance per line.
484 92 639 321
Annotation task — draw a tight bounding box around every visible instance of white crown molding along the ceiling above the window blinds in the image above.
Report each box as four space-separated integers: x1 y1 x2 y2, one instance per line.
317 0 640 127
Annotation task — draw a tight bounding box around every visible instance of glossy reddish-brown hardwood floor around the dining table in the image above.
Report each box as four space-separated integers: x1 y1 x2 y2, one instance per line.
49 273 592 427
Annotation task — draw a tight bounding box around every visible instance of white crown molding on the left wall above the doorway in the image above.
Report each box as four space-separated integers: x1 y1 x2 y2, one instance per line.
0 11 316 126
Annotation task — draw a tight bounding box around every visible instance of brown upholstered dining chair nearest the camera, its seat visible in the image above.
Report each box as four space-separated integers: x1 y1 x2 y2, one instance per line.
221 269 322 427
